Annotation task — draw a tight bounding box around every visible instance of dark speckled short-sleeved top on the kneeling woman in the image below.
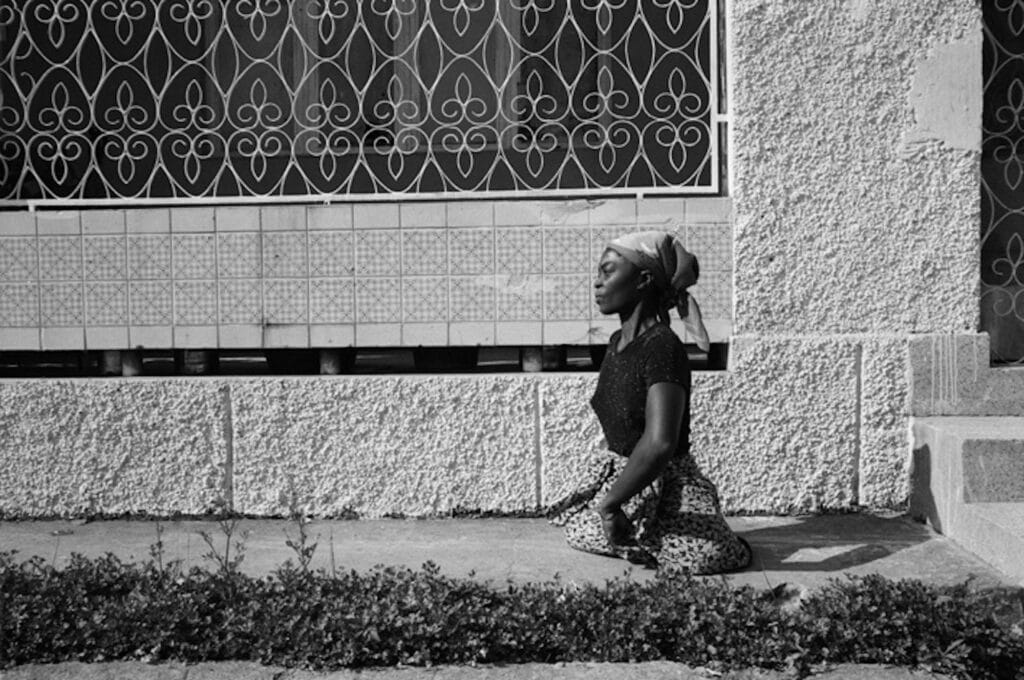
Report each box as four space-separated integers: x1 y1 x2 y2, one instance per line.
590 324 690 458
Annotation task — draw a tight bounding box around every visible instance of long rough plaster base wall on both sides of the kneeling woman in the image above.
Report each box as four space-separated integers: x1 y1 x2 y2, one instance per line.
0 338 905 517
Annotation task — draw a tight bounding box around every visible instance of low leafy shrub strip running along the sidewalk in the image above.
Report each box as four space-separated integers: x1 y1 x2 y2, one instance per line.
0 553 1024 680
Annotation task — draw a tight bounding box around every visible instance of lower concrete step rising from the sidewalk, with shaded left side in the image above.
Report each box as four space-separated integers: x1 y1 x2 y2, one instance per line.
910 417 1024 584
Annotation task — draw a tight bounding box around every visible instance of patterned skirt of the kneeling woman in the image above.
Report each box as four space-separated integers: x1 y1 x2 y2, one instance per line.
551 453 752 575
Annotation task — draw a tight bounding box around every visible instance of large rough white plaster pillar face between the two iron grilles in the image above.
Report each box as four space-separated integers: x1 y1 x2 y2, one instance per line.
729 0 981 335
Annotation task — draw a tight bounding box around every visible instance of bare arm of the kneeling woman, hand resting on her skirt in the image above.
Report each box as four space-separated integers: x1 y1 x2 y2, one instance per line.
597 382 687 542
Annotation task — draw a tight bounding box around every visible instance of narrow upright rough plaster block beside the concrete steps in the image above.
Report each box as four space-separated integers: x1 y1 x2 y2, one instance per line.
859 336 911 508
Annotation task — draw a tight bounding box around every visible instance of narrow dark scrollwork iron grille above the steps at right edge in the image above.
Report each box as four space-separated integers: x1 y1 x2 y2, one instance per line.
981 0 1024 364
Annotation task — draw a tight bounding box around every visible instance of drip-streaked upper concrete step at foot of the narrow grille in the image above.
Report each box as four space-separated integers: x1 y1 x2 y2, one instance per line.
907 334 1024 416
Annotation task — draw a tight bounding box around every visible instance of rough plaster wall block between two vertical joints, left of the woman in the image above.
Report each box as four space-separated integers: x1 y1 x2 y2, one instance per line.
231 376 537 517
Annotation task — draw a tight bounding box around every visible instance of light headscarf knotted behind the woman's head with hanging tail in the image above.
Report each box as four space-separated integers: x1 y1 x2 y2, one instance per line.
608 231 711 351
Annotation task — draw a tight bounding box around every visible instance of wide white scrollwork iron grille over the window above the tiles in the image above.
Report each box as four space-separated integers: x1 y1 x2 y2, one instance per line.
0 0 718 202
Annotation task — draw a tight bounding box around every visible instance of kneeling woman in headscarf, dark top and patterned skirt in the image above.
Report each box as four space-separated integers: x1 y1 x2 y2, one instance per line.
553 231 751 573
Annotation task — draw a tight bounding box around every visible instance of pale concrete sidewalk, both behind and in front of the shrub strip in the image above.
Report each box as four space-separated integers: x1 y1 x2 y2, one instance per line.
0 514 1019 680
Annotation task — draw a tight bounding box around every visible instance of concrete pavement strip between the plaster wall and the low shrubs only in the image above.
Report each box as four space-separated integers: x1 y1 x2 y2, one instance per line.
0 514 1019 589
